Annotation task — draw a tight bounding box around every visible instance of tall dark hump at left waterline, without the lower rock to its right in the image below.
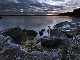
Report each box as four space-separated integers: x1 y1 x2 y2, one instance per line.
1 27 27 44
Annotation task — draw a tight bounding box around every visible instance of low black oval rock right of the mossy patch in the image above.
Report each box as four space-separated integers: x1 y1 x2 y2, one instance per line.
41 37 62 48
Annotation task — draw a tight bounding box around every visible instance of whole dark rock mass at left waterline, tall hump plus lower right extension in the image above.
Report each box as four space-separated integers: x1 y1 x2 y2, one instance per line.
0 27 37 44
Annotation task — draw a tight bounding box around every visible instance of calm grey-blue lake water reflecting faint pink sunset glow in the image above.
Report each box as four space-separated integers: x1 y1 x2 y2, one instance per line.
0 16 72 35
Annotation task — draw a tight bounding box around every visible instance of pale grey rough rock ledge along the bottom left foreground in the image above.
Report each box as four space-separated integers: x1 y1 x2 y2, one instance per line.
0 35 61 60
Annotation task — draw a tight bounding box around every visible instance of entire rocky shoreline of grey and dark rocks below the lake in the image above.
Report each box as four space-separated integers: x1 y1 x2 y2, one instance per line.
0 21 80 60
